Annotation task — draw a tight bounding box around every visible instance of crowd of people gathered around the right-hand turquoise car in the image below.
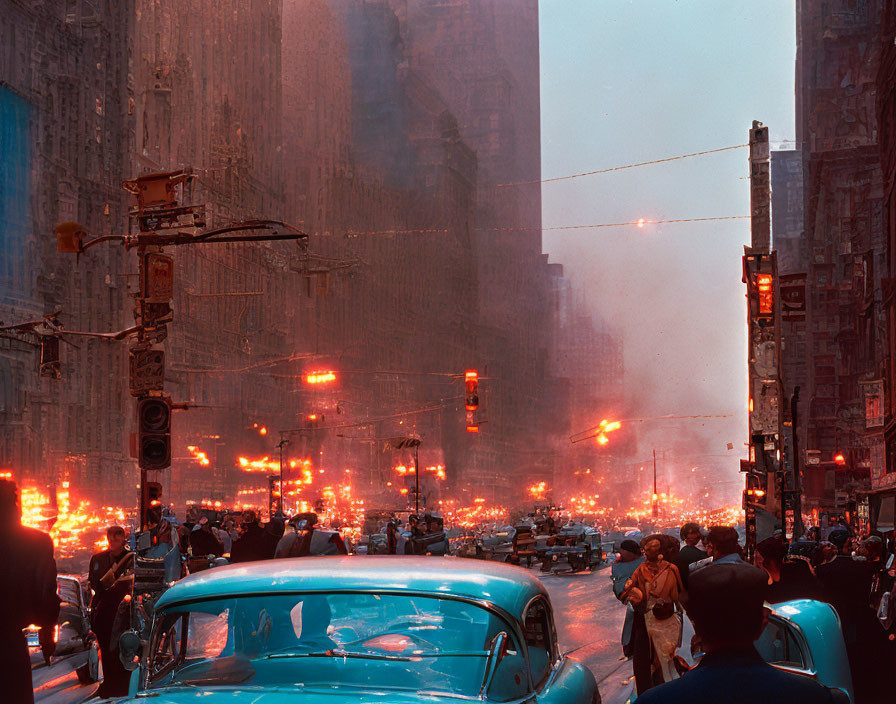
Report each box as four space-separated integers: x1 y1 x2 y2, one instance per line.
612 523 896 704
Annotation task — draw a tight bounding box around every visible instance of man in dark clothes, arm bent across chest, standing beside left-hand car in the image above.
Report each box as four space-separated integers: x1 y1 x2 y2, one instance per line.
88 526 134 699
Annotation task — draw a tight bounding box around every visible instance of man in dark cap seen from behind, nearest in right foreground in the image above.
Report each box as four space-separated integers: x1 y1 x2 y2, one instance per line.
638 562 848 704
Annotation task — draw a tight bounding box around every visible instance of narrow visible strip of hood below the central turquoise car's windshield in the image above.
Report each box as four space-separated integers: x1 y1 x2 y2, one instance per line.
107 685 467 704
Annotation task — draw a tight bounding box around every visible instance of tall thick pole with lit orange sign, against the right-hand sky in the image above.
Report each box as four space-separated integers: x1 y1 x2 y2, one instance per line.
741 120 784 559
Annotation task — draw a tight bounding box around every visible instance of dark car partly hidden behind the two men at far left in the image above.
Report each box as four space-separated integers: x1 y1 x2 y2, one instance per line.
25 574 99 684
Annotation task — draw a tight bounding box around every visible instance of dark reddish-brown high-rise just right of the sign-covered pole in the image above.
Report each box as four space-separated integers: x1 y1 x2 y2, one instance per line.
796 0 887 508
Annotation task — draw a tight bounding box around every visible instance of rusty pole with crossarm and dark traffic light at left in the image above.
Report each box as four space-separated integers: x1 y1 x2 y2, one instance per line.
55 169 308 530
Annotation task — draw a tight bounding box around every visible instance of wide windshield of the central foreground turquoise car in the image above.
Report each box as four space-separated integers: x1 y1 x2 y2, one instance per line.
148 593 522 696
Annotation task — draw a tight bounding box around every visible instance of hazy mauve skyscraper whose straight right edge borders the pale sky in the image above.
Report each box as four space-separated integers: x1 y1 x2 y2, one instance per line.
346 0 565 494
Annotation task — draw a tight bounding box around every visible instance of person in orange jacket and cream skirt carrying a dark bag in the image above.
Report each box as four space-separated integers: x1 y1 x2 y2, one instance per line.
625 533 684 682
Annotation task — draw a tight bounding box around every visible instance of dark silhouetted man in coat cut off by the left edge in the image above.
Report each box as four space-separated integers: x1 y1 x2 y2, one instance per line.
0 479 59 704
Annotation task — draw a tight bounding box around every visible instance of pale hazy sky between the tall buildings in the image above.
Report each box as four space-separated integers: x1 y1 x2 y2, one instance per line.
540 0 796 498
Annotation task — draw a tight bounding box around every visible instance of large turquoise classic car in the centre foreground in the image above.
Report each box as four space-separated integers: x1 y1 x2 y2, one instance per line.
108 556 600 704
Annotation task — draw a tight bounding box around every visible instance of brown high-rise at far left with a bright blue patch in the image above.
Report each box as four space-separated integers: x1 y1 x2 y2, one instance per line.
0 0 134 502
